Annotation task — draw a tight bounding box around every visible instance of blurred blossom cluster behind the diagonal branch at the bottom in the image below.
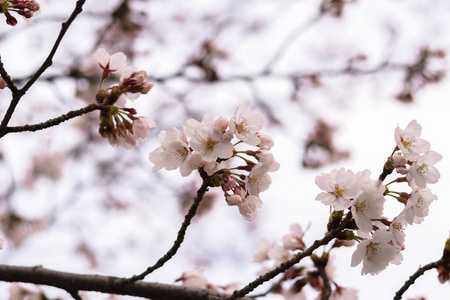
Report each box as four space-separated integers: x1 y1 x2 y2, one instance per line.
253 224 357 300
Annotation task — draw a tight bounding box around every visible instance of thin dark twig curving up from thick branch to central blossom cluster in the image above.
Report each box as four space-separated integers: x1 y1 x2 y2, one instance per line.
124 174 210 284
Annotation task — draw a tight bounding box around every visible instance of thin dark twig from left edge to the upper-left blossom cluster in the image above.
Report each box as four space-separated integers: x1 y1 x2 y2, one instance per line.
0 103 102 137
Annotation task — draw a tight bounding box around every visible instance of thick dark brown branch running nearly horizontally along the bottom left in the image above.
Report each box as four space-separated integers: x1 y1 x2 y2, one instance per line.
0 265 250 300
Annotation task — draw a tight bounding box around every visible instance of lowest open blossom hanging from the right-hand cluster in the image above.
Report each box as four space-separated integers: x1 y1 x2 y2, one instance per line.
351 230 397 275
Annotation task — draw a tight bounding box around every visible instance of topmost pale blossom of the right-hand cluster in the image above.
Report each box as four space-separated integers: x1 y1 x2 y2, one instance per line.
395 120 430 161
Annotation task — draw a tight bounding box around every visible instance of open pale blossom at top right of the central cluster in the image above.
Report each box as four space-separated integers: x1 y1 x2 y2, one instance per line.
229 105 264 146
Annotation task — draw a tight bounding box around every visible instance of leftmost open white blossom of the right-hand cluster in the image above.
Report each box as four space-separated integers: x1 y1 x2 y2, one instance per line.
315 168 362 210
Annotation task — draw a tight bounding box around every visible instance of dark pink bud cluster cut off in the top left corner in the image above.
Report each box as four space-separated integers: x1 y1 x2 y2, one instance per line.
0 0 40 26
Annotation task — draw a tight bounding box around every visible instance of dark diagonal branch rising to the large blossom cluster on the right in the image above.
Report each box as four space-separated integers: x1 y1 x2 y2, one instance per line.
229 212 352 299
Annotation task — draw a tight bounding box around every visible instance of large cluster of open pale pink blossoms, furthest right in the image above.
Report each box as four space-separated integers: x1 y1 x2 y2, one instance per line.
315 120 442 275
